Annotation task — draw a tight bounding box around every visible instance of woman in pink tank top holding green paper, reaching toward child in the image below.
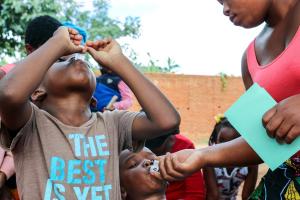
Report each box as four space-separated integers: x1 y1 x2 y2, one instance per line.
155 0 300 200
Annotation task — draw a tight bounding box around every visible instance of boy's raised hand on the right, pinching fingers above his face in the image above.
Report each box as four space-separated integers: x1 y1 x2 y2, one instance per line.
86 38 123 69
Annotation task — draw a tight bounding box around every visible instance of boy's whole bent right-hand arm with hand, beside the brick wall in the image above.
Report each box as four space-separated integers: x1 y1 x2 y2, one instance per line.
87 39 180 140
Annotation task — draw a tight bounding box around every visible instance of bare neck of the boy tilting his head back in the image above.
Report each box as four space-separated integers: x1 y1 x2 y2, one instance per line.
41 95 91 126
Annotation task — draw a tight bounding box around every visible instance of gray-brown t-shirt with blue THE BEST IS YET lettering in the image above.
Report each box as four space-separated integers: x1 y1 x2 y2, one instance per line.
0 105 137 200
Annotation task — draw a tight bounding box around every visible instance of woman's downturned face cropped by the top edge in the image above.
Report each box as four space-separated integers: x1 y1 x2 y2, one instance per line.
218 0 271 28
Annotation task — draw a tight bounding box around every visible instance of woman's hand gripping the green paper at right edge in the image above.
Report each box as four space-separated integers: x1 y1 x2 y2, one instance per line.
263 95 300 144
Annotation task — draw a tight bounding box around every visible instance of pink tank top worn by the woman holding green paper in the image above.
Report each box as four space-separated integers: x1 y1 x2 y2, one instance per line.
247 27 300 162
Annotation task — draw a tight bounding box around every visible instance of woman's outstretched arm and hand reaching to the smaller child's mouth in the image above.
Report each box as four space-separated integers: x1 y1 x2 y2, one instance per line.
156 137 262 181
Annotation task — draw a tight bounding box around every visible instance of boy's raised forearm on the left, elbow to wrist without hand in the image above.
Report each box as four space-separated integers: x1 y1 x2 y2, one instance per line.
0 38 63 104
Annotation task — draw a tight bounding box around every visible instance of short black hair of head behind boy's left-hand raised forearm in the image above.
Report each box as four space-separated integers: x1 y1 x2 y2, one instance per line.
25 15 62 49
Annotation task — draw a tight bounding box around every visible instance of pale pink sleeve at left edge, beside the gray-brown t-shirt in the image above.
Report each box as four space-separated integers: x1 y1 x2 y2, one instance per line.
0 148 15 179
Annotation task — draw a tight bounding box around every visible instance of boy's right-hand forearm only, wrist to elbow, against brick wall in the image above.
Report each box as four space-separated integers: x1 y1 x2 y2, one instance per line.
110 56 180 131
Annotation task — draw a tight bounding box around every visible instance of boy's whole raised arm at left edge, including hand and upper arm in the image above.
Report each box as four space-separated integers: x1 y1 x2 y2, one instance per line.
0 27 82 132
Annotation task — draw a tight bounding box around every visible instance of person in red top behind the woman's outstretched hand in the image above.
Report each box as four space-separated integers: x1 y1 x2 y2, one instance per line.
145 133 205 200
